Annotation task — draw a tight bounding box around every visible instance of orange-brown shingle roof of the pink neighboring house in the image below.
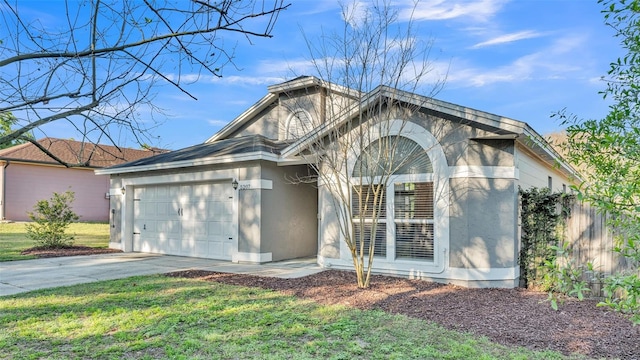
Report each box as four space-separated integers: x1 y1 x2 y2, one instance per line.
0 138 166 168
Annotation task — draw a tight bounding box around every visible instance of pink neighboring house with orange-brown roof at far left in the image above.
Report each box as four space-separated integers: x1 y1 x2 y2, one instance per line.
0 138 165 222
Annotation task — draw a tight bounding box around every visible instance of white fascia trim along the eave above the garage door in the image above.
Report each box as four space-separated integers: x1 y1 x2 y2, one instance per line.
95 151 281 175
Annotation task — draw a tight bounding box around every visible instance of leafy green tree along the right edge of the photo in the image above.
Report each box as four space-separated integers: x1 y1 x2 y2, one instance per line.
560 0 640 322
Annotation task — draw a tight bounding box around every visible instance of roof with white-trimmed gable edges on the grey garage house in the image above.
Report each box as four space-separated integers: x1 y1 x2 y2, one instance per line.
99 76 579 181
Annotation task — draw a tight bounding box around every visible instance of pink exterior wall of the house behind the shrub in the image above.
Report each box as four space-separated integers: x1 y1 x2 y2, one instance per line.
5 163 109 222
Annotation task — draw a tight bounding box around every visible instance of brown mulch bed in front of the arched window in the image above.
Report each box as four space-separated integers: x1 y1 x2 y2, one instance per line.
167 270 640 359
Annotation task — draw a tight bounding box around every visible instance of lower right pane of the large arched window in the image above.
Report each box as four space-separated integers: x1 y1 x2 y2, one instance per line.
396 223 433 260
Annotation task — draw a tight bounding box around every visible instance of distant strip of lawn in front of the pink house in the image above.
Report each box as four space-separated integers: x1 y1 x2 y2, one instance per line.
0 223 109 261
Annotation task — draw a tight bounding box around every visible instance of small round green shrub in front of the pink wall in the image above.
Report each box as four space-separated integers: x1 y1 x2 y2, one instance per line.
25 190 80 248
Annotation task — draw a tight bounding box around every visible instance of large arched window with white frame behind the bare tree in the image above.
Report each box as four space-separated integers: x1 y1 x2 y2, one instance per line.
351 136 435 261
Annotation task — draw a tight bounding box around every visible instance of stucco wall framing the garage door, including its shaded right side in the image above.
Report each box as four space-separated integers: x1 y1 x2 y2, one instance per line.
111 161 317 261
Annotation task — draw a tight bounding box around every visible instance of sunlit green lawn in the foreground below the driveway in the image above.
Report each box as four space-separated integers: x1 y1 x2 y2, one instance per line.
0 275 584 359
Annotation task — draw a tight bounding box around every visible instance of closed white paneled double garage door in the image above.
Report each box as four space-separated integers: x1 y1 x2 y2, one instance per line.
133 182 237 260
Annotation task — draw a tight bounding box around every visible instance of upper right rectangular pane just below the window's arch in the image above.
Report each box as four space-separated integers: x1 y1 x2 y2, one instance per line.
393 182 433 220
